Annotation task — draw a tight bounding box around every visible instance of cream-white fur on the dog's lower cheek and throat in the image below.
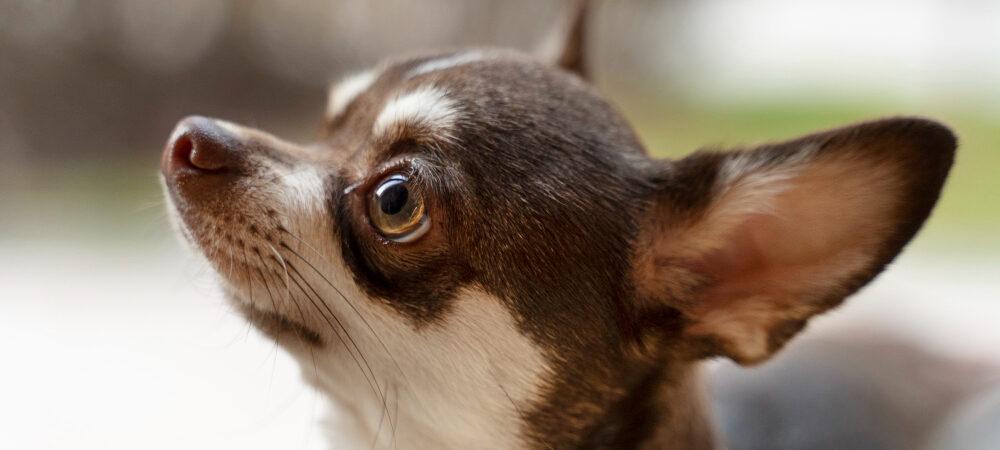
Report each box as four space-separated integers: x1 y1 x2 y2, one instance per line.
299 290 546 449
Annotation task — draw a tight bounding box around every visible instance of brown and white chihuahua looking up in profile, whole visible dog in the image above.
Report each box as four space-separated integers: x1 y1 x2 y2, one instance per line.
161 2 956 449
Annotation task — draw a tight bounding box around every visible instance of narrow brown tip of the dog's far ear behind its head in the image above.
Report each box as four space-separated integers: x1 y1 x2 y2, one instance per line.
538 0 590 79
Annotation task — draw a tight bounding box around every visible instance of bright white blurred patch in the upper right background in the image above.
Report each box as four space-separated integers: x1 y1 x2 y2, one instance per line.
672 0 1000 100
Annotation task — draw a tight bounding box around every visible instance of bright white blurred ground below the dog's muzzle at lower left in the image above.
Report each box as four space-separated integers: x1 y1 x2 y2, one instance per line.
0 243 325 449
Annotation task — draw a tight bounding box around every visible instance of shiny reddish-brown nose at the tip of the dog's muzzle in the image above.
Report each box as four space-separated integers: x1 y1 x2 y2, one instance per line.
160 116 247 177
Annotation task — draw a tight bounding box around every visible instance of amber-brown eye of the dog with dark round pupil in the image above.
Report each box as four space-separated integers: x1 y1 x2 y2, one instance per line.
368 174 430 243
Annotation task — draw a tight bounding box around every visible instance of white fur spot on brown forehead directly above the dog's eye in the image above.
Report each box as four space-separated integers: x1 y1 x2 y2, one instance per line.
372 86 461 139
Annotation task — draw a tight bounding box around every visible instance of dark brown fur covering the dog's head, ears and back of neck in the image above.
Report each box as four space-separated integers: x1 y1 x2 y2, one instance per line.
164 3 956 449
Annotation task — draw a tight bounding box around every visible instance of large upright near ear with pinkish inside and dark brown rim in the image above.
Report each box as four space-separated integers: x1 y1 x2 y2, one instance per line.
634 118 956 364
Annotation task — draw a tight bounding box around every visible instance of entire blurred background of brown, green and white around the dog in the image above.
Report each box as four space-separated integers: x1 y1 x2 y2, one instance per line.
0 0 1000 450
